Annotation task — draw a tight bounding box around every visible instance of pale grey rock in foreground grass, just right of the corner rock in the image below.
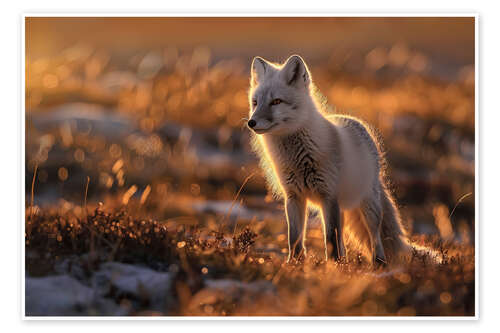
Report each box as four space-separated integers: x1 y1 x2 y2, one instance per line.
92 262 174 311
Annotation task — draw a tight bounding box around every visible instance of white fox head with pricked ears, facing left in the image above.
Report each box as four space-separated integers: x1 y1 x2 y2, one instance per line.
248 55 313 135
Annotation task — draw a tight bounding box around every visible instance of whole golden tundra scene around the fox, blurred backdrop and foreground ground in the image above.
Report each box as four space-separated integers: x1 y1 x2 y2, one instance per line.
24 17 475 316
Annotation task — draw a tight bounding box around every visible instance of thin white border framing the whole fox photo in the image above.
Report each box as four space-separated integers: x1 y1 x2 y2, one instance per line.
19 11 480 321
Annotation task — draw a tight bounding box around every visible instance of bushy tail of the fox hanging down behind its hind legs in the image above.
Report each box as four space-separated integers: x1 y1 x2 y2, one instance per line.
381 189 412 263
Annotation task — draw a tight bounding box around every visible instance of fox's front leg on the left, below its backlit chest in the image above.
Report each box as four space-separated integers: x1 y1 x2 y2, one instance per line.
285 195 306 262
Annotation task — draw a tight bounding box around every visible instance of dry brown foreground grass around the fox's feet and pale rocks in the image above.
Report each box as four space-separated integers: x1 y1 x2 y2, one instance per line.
26 201 474 316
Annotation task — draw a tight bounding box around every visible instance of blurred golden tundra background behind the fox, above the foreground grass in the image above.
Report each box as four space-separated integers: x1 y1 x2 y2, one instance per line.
25 17 475 252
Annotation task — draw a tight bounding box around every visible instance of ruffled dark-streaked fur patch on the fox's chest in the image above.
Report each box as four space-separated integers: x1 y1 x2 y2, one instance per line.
275 135 326 194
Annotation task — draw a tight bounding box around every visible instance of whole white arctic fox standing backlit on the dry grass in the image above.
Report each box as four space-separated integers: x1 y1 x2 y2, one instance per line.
247 55 410 266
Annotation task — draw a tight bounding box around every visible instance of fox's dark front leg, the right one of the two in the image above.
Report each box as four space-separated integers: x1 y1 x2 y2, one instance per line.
321 198 345 261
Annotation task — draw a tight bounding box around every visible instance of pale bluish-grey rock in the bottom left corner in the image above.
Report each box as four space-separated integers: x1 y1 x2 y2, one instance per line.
25 275 126 316
